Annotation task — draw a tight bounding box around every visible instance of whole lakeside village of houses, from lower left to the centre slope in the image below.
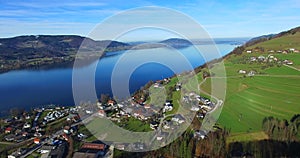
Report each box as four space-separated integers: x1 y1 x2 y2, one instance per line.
0 78 215 158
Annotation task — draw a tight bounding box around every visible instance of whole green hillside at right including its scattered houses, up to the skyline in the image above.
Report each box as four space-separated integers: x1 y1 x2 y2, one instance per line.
201 28 300 135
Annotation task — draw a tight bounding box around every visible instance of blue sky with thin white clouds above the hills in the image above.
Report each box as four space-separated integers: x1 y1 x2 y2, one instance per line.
0 0 300 41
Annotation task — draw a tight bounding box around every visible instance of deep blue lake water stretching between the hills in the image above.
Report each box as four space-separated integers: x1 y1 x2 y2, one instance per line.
0 44 236 114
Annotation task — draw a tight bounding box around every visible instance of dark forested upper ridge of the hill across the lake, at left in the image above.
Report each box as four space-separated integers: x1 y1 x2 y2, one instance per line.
0 35 129 59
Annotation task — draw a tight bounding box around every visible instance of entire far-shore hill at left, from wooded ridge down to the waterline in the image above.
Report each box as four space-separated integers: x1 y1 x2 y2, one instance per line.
0 35 132 72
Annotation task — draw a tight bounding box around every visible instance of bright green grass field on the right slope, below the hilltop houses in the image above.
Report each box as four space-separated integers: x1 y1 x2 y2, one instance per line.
201 53 300 134
